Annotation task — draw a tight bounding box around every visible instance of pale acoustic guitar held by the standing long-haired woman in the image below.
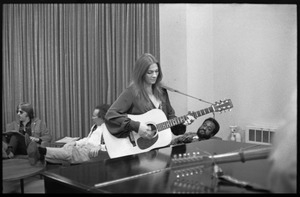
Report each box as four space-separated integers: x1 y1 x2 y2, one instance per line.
103 99 233 158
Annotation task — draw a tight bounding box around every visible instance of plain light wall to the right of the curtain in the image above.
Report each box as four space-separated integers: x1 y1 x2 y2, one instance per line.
160 4 297 139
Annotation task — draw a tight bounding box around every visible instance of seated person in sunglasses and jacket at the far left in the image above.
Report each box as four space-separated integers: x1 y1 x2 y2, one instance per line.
2 102 52 158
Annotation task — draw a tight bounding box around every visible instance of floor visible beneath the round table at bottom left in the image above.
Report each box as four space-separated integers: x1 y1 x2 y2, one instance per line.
2 175 45 194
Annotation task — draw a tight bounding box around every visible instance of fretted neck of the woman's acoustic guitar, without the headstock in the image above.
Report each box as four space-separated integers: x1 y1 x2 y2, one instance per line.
156 106 214 131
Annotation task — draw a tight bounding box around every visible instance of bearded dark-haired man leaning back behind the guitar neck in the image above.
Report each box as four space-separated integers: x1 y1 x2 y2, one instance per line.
171 118 220 145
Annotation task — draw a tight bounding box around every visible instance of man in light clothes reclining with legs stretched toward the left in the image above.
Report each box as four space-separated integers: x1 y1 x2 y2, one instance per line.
27 104 110 165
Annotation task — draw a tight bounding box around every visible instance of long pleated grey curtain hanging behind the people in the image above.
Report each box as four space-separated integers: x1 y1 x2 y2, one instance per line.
2 4 160 140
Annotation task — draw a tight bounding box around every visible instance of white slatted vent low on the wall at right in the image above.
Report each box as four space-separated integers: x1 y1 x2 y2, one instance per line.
245 126 276 145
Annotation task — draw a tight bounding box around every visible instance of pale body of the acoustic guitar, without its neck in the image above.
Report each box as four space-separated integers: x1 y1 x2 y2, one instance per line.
103 109 172 158
